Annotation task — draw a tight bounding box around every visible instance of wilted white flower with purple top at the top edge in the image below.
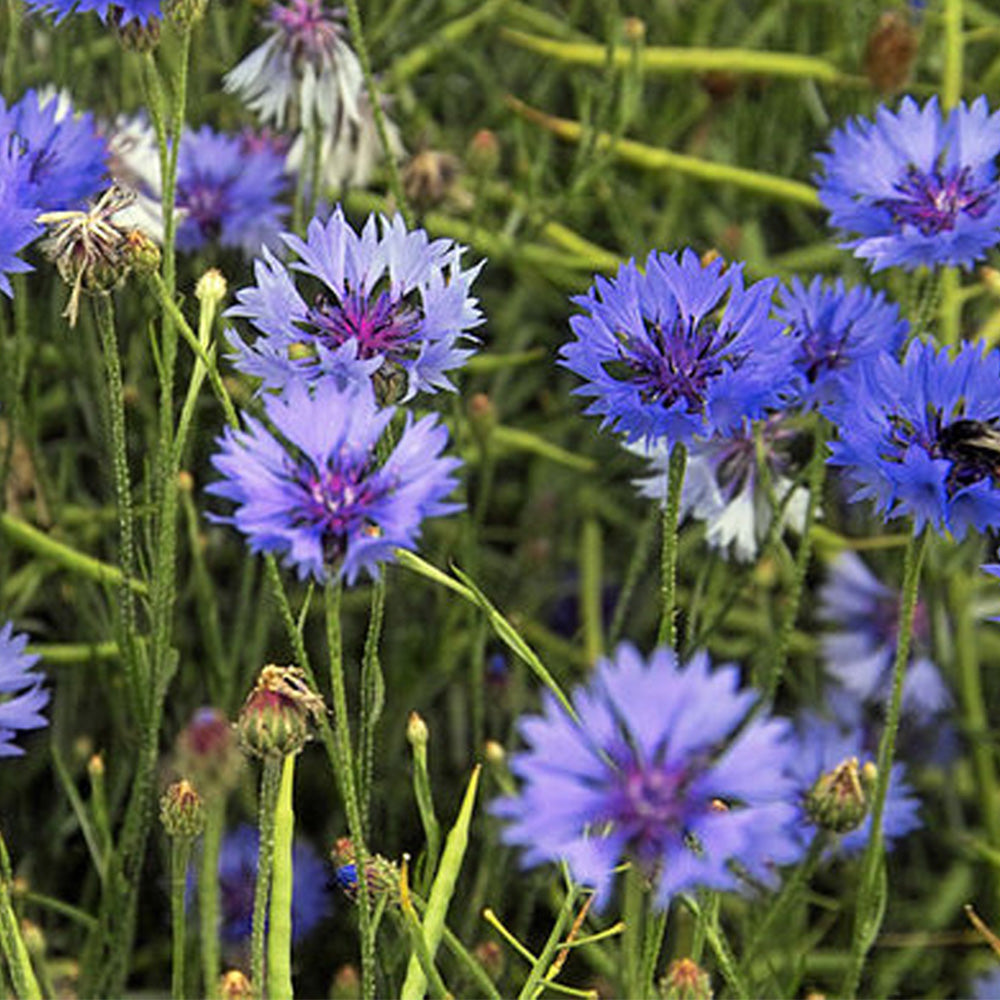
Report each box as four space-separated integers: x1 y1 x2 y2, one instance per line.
224 0 364 132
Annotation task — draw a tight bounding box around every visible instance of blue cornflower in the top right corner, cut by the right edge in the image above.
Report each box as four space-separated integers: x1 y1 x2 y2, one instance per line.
816 97 1000 271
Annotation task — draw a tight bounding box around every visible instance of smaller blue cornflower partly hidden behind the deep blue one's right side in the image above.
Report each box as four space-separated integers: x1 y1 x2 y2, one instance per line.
777 277 909 405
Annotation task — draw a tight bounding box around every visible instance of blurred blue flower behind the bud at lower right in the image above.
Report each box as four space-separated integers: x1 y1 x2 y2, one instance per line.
792 712 922 854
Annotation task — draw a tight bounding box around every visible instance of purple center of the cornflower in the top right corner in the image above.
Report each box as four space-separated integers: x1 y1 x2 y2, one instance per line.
875 165 997 236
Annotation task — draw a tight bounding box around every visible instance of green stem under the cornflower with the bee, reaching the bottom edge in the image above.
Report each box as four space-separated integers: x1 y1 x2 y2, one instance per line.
842 529 928 1000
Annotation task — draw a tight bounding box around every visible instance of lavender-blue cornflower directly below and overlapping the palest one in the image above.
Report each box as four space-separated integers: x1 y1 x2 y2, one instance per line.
208 381 461 584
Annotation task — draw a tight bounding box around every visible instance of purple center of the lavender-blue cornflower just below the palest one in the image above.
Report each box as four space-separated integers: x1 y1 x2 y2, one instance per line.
293 462 380 564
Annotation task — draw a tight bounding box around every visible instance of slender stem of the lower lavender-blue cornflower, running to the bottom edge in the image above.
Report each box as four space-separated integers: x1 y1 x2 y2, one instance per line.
324 578 375 1000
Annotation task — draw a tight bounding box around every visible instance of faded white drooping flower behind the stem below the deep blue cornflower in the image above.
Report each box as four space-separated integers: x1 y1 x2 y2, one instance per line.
630 414 809 562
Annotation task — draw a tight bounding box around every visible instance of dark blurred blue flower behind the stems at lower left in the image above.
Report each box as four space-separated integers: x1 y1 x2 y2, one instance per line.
199 823 331 944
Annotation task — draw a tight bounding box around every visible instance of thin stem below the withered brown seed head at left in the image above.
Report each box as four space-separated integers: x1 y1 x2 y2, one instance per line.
94 295 149 719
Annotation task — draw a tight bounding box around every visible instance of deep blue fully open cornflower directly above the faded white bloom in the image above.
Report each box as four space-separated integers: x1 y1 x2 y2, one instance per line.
561 250 794 443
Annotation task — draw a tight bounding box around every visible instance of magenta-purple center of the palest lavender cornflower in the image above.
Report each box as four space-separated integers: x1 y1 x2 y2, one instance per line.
307 292 421 360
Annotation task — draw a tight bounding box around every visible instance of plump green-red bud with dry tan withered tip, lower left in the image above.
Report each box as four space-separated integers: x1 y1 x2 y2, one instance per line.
236 664 324 757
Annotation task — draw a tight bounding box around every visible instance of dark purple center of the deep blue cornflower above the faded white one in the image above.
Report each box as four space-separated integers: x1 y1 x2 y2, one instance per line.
609 320 747 413
